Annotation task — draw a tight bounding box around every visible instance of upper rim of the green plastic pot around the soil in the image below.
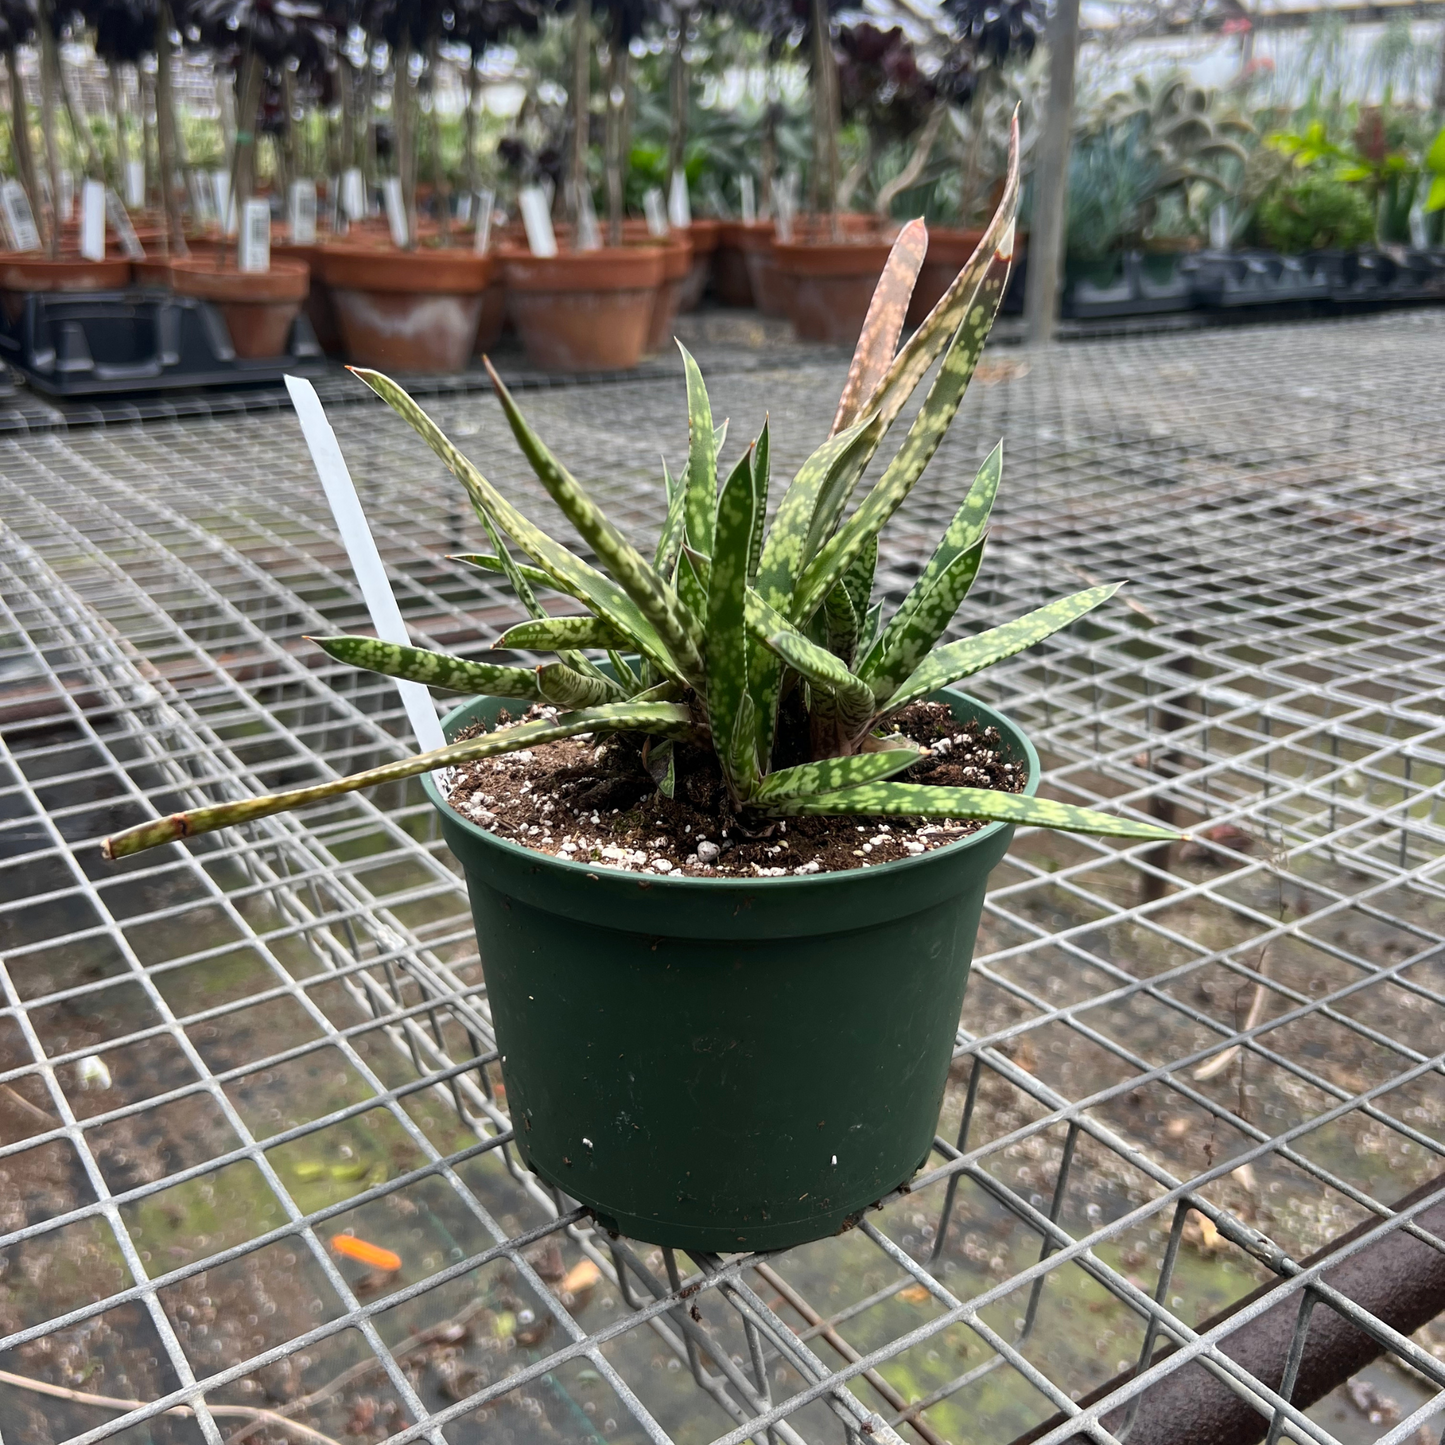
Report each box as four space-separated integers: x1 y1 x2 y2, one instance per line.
422 688 1042 897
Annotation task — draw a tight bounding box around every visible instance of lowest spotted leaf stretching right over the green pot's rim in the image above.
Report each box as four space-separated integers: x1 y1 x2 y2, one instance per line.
767 783 1179 841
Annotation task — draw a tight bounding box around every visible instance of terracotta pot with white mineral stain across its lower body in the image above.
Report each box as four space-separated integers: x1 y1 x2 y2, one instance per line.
321 241 494 373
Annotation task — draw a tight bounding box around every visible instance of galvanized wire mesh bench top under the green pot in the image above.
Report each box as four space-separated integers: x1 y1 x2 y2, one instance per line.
0 312 1445 1445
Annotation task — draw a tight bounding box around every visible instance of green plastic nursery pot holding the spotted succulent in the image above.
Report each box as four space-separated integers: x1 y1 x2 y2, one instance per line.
423 691 1039 1253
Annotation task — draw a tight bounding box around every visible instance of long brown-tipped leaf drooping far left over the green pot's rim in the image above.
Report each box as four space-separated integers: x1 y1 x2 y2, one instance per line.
101 701 695 858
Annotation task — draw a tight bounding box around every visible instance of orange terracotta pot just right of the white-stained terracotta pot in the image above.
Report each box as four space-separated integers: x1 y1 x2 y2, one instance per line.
500 246 665 371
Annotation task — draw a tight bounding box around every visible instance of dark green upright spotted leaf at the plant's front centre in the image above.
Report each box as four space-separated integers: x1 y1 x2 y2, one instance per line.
705 454 757 802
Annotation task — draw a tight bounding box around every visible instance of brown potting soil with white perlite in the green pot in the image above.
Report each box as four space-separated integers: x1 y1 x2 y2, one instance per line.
444 702 1027 879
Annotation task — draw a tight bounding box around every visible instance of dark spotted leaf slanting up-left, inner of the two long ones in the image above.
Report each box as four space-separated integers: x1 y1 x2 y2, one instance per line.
484 361 702 686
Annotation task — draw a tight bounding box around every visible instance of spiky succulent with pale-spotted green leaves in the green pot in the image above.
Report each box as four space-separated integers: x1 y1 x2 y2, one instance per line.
105 127 1175 858
